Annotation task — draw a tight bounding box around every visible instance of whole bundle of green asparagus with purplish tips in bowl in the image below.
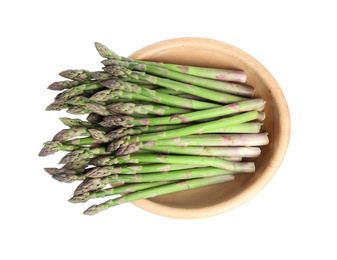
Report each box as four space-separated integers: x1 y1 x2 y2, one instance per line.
39 43 269 215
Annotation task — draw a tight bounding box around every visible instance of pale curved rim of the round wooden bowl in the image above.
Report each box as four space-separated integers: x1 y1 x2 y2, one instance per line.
129 37 291 219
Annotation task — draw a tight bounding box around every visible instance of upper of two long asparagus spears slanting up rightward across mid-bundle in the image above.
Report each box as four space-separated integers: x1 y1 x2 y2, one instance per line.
98 99 265 127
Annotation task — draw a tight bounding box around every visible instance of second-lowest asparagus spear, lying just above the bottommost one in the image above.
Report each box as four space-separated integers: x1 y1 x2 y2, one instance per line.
69 181 173 203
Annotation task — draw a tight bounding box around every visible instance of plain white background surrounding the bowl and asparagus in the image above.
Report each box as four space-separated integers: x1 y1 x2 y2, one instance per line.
0 0 337 260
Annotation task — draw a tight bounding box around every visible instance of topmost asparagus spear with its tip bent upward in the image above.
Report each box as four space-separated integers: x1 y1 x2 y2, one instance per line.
95 42 247 83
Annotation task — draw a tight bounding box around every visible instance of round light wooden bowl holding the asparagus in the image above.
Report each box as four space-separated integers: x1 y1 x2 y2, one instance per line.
130 37 290 219
